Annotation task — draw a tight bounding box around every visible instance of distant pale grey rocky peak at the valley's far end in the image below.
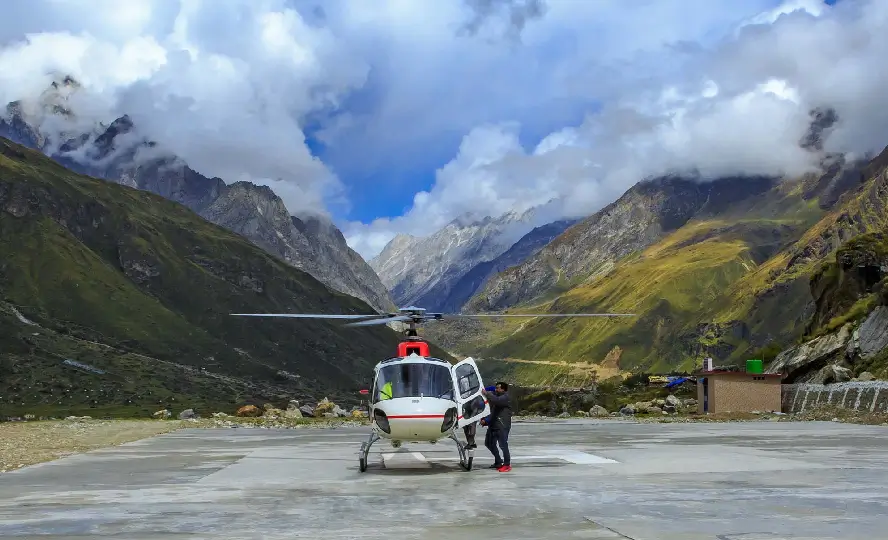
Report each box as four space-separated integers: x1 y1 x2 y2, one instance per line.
370 210 535 311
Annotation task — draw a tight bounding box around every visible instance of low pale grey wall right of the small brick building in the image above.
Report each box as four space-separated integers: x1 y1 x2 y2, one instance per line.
781 381 888 414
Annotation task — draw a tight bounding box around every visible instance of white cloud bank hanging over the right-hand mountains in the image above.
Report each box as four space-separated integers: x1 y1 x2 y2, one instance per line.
346 0 888 256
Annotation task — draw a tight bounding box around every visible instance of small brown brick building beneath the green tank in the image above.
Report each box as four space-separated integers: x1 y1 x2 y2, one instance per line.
696 371 783 414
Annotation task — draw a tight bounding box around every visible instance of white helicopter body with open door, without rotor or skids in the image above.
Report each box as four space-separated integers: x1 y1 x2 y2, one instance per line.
369 354 490 444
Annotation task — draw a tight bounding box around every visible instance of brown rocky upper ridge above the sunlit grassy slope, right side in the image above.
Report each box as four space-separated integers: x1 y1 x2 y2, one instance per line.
466 108 862 312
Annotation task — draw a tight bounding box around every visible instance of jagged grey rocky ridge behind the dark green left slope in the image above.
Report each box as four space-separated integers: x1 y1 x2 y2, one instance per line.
0 88 394 311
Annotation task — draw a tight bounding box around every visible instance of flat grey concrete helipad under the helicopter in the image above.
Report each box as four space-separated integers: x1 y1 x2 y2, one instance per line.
0 420 888 540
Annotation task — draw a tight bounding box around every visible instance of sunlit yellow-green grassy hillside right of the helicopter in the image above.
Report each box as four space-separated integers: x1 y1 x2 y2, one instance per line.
481 215 812 372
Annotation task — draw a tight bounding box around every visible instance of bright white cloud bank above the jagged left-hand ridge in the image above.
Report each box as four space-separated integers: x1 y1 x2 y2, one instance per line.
0 0 367 212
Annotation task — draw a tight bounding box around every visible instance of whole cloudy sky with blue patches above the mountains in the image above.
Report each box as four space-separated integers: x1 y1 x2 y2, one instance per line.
0 0 888 259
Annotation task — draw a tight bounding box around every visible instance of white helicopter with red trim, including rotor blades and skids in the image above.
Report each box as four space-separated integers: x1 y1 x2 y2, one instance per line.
231 306 634 472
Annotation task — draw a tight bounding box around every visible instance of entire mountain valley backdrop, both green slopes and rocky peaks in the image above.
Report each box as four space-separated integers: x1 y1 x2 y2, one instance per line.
0 81 888 414
